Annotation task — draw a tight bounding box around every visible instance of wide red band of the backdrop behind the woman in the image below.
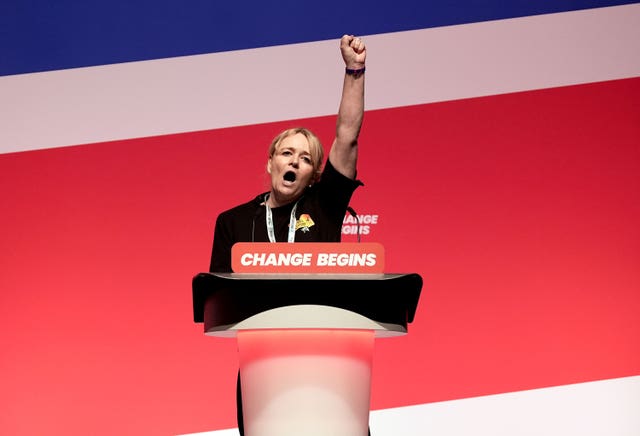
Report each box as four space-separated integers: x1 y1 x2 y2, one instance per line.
0 79 640 435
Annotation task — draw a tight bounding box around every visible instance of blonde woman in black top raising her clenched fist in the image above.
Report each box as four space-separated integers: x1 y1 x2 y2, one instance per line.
210 35 366 435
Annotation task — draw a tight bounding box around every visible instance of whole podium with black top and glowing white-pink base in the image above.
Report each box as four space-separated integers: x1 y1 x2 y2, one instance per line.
192 273 422 436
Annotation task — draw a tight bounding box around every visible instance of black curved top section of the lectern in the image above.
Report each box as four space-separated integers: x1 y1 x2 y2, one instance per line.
192 273 422 329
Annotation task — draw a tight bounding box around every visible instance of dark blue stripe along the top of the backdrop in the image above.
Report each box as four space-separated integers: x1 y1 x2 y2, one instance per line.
0 0 636 76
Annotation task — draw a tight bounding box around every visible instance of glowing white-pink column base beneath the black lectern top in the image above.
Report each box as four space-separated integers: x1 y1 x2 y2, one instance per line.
238 330 374 436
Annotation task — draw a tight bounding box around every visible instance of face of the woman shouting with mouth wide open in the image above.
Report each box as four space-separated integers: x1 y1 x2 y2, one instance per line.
267 133 315 207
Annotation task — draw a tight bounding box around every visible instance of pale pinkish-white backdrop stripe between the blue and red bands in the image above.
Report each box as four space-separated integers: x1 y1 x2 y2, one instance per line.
0 4 640 153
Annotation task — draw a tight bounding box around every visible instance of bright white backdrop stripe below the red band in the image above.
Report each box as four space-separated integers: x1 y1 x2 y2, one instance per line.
179 376 640 436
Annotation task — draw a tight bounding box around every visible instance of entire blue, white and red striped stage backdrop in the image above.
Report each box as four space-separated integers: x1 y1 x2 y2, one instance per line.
0 0 640 436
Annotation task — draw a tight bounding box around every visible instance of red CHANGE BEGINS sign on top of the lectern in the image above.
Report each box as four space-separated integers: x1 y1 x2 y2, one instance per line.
231 242 384 274
